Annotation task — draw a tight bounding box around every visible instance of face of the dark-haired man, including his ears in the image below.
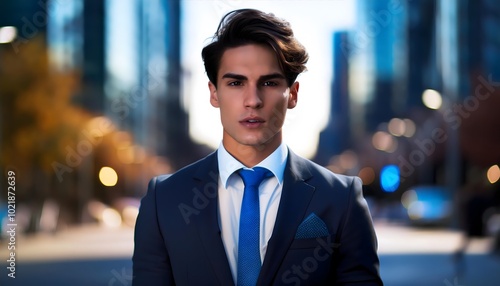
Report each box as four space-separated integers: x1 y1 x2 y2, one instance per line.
209 44 299 152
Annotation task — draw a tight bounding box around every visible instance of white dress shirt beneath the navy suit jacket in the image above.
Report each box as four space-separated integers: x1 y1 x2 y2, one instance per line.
217 143 288 283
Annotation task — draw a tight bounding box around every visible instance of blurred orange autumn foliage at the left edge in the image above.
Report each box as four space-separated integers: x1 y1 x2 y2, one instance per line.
0 37 90 172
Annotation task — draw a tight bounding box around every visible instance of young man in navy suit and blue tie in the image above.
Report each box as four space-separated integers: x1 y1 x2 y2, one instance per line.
133 9 382 286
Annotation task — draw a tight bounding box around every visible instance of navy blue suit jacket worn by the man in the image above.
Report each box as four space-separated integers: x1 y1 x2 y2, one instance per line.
133 151 382 286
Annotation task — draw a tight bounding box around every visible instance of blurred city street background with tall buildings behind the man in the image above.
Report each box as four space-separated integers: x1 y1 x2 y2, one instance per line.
0 0 500 285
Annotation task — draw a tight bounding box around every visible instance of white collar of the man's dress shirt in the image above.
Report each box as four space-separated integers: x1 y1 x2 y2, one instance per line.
217 142 288 188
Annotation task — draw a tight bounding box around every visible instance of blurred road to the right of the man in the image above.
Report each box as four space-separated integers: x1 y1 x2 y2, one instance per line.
375 223 500 286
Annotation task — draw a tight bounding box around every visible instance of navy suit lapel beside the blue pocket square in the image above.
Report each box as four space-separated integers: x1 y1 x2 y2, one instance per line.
257 151 314 285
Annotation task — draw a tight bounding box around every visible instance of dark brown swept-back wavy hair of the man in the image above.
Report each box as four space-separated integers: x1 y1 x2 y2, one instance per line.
201 9 309 86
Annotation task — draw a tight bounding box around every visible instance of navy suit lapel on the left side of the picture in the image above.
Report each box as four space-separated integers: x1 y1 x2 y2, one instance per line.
193 152 234 285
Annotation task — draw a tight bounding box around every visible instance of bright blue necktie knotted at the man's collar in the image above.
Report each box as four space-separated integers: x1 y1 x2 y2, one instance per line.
237 167 272 286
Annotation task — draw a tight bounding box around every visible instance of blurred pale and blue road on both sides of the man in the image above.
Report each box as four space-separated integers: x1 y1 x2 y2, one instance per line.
0 223 500 286
